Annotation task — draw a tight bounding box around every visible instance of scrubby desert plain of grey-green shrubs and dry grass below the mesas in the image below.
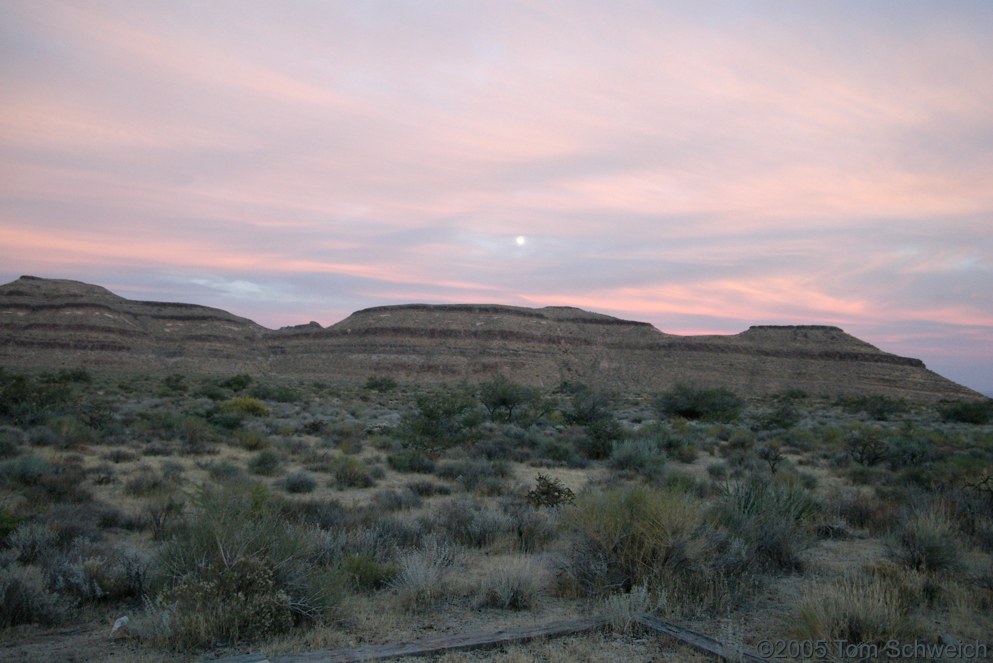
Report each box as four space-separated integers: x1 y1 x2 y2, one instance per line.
0 369 993 660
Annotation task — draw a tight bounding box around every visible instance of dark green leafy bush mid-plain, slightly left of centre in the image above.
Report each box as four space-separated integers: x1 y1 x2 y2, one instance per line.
401 385 482 453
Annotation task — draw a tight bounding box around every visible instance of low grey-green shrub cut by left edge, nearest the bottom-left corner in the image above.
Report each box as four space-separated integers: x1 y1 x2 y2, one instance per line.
0 564 75 627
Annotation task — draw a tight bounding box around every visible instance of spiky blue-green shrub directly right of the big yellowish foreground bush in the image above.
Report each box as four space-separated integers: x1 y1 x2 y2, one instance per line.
717 478 821 569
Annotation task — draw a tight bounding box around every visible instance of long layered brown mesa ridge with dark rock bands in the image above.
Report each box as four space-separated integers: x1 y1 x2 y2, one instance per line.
0 277 978 400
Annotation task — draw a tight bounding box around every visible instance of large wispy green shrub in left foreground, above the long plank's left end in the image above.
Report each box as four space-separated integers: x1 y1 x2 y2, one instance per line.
155 486 340 647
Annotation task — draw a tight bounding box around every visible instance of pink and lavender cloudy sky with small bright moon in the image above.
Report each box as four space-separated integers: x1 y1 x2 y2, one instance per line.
0 0 993 394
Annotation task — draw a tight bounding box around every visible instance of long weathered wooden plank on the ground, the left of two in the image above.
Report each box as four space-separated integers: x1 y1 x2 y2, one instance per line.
212 617 607 663
